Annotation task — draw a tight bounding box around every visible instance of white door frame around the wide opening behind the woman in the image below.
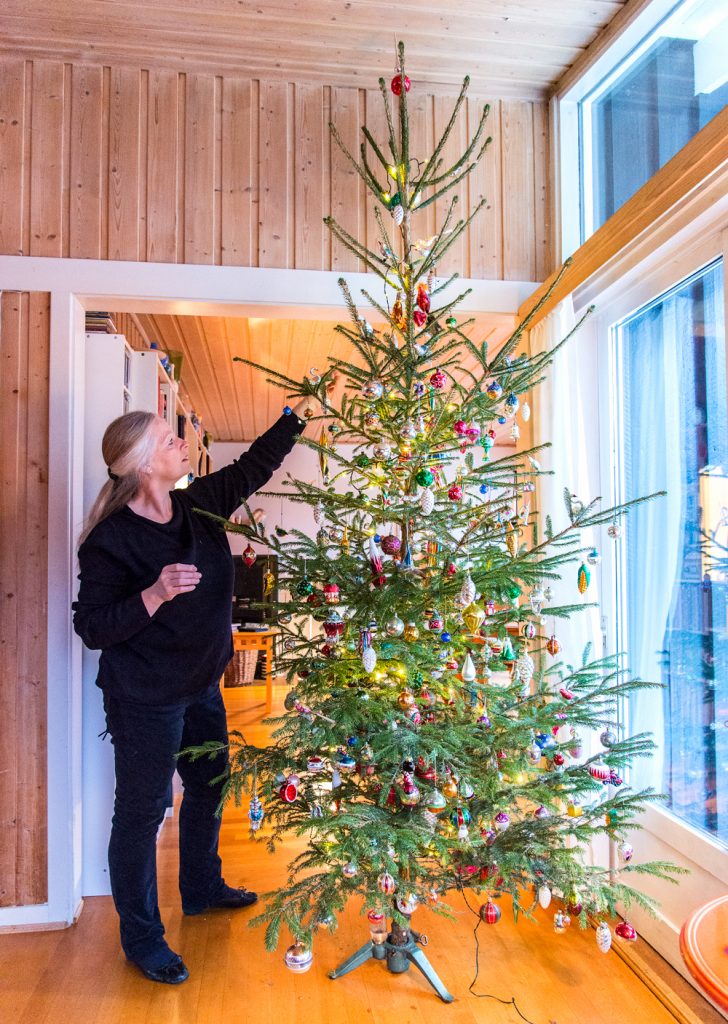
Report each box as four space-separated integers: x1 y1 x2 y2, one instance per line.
0 256 539 931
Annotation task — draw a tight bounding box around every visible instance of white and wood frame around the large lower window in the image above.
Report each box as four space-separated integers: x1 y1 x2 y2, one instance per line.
589 214 728 984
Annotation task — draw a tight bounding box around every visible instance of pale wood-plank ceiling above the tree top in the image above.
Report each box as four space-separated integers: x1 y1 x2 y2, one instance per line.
0 0 626 98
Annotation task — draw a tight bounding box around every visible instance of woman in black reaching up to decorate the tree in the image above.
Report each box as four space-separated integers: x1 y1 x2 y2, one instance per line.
74 399 306 984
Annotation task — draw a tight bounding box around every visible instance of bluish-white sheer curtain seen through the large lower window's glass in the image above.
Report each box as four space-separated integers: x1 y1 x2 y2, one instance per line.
617 296 691 792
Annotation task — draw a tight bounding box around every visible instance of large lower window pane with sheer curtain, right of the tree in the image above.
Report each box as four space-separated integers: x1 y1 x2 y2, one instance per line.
612 259 728 841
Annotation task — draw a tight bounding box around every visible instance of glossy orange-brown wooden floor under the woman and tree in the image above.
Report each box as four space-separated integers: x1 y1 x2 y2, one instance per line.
0 687 712 1024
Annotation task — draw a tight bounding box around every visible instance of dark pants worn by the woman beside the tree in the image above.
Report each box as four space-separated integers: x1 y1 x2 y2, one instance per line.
103 684 227 969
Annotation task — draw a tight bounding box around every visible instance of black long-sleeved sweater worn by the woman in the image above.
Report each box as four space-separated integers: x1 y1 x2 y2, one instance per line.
74 415 303 705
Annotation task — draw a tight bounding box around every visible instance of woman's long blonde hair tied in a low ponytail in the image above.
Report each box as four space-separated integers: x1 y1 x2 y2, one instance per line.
79 412 159 547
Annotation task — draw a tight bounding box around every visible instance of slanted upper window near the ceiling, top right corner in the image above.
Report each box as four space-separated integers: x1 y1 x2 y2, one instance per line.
579 0 728 242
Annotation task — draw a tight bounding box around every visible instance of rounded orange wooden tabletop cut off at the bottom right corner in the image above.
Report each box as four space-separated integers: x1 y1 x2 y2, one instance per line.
680 896 728 1010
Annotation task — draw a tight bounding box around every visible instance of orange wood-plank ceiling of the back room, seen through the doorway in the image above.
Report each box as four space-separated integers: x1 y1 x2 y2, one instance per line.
137 313 515 441
